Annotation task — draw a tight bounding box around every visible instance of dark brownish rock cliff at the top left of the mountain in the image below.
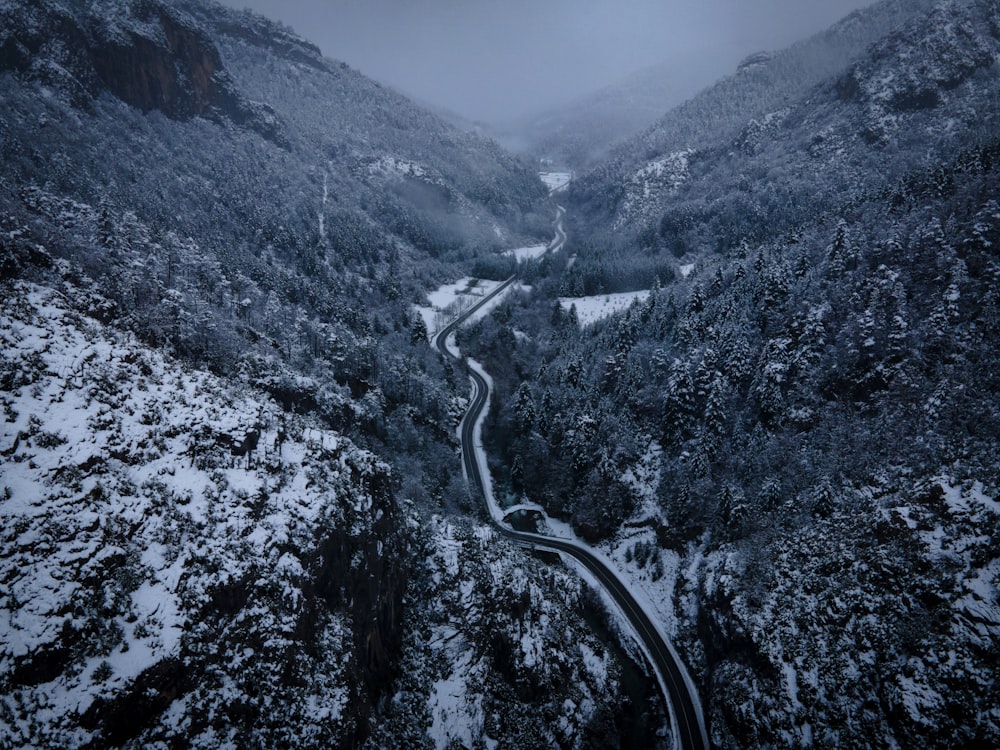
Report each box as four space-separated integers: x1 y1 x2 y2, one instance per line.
0 0 280 140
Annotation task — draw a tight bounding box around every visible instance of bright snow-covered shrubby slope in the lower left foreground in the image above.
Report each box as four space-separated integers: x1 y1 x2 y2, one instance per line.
0 283 383 747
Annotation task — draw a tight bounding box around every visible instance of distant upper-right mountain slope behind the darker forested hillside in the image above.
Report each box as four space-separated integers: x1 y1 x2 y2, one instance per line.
572 3 998 284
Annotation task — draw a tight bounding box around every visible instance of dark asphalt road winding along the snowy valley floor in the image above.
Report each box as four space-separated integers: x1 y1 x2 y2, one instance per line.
432 207 709 750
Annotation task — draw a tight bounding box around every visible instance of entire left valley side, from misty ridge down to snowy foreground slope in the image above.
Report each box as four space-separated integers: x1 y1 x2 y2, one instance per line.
0 0 655 748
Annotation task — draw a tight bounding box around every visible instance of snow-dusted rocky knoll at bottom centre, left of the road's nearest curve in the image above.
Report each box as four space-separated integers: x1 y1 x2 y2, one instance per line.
399 516 621 750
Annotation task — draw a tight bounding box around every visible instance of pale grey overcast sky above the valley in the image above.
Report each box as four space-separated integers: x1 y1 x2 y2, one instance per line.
217 0 872 122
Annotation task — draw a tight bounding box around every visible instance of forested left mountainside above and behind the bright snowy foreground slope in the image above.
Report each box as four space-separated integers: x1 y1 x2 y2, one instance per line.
0 2 550 500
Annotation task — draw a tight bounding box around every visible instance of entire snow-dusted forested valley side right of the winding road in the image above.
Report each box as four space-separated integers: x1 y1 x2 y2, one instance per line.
465 1 1000 748
